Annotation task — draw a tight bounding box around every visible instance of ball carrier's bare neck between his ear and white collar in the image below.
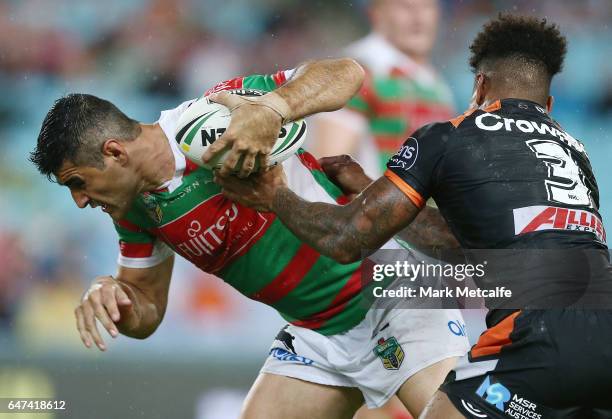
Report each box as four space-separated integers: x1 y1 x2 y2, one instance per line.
138 124 176 192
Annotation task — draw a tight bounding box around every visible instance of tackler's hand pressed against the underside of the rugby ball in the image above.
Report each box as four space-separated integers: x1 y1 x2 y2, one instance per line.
215 165 287 212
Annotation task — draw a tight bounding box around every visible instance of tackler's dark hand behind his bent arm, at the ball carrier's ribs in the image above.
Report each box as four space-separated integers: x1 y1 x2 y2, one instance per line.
319 154 372 198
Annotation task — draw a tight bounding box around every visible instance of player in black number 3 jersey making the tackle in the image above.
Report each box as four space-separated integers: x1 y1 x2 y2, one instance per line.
218 14 612 419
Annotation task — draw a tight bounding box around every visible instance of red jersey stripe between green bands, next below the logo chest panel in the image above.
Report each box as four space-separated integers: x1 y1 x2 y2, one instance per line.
251 244 321 305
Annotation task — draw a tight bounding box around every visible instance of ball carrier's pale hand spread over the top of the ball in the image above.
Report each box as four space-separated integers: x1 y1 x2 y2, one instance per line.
202 92 281 178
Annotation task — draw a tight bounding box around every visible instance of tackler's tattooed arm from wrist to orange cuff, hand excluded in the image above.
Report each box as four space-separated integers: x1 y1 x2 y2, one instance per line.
273 177 419 263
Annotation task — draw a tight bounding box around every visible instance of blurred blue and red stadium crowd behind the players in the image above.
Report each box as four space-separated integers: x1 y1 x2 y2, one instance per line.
0 0 612 418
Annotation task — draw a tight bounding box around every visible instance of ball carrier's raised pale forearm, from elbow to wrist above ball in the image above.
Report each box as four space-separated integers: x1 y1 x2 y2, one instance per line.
275 58 364 120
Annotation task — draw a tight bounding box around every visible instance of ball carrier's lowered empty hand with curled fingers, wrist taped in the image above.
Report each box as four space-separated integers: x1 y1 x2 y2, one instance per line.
74 276 132 351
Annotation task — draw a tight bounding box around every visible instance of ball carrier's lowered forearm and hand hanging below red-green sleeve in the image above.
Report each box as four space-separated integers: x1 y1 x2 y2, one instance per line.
74 257 174 351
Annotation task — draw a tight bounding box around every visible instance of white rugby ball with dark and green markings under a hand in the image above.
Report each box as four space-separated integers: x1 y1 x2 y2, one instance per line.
175 89 306 170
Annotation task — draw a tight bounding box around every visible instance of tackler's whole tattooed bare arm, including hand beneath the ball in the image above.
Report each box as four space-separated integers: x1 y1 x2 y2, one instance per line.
216 166 420 263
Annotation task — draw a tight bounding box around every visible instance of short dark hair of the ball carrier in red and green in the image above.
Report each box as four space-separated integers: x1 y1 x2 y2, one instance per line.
30 93 141 181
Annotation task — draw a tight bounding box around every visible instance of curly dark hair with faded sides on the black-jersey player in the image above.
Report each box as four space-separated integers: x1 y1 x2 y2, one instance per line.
470 13 567 83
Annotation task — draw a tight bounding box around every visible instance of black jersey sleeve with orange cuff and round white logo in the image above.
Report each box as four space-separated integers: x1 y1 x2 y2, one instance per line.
385 123 450 208
